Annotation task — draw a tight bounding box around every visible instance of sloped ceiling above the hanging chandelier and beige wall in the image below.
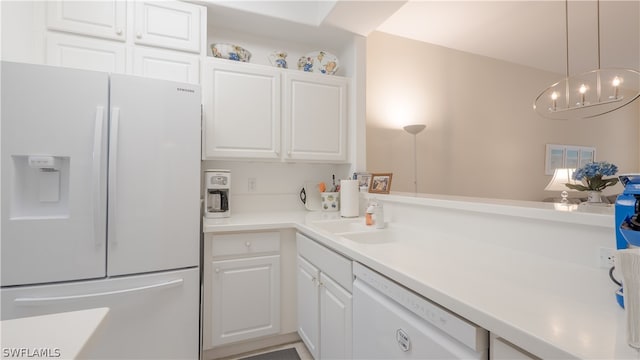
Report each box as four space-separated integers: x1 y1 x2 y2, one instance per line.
376 0 640 74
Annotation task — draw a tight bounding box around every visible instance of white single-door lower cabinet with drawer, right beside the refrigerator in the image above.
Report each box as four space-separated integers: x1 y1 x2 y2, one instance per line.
203 232 281 350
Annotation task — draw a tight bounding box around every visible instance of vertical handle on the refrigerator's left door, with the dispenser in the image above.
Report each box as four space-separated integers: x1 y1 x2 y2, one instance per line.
92 106 106 246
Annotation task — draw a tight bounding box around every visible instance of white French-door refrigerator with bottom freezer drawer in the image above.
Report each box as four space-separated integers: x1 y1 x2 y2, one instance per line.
0 62 201 359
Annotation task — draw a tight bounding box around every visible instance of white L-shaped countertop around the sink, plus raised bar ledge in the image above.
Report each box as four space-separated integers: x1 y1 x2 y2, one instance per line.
204 199 640 359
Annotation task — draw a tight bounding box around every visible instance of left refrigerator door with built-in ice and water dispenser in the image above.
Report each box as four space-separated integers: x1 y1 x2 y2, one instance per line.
0 62 109 286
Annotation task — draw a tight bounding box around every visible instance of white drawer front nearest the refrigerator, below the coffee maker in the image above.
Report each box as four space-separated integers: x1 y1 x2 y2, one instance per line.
211 231 280 258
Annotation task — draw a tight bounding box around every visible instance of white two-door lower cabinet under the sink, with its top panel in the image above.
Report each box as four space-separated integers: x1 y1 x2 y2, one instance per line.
296 234 352 360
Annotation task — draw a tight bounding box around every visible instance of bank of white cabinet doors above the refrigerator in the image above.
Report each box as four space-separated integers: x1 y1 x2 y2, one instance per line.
41 0 207 84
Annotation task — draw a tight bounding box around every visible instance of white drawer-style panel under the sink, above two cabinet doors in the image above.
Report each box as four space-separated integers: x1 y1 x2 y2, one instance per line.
296 233 353 292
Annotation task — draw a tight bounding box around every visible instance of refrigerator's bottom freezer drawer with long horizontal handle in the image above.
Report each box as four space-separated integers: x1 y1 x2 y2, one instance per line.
0 268 199 359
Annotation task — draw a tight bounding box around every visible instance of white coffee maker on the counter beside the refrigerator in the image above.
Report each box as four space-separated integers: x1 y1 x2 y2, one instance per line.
204 170 231 218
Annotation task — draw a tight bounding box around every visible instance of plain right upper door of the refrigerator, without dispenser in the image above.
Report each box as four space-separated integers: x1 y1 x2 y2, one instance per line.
107 75 200 276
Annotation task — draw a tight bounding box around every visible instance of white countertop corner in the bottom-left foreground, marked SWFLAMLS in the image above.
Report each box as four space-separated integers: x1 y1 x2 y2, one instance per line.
0 308 109 359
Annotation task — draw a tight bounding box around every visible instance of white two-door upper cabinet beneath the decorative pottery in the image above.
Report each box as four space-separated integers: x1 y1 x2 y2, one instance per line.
201 59 348 163
